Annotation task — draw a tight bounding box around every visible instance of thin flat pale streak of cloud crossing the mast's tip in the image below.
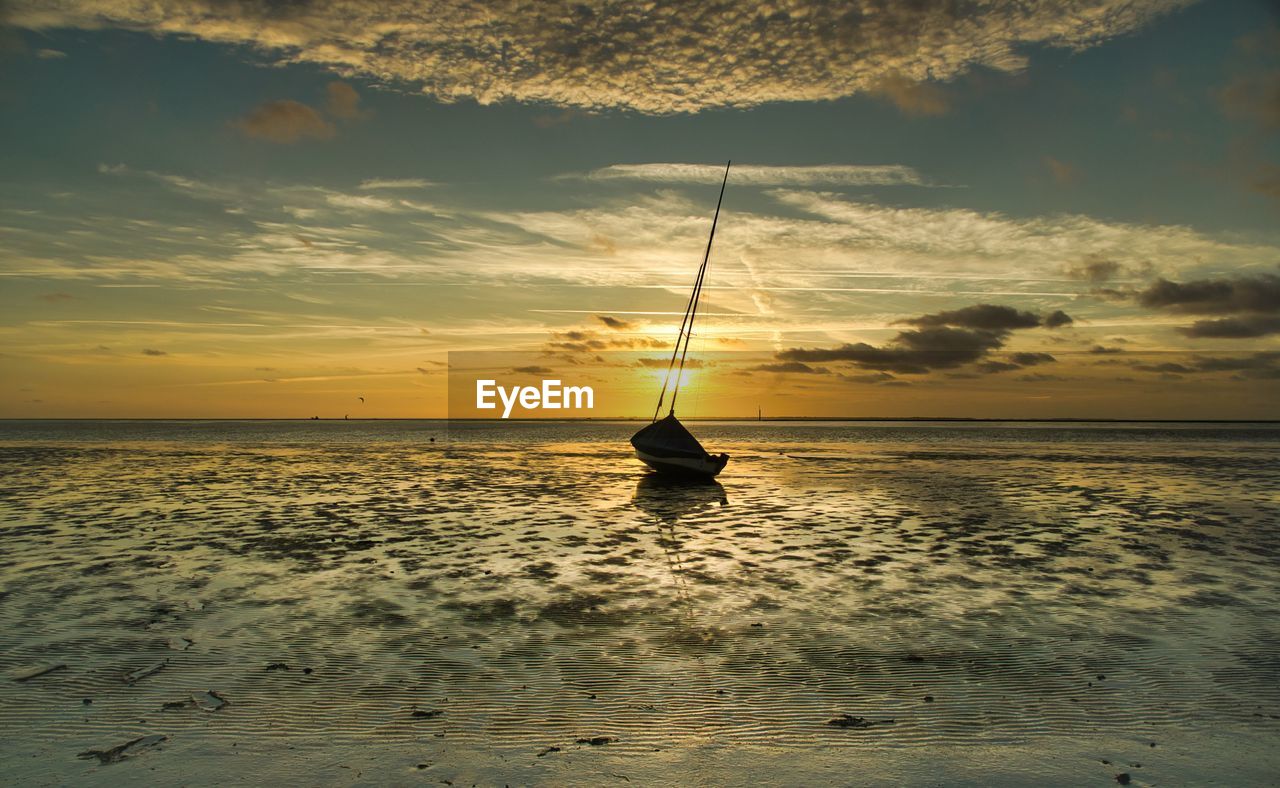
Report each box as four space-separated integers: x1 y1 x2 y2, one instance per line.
566 162 929 185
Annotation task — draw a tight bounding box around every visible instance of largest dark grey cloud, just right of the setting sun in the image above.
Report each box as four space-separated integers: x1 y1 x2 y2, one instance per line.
776 304 1053 375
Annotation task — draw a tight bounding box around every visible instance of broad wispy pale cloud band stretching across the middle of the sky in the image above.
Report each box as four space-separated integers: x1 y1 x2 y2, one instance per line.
45 164 1280 303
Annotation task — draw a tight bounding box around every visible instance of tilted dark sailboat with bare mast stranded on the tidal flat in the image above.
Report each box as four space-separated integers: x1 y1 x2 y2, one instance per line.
631 161 733 478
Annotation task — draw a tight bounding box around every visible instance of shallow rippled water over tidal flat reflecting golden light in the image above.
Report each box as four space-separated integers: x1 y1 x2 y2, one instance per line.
0 422 1280 785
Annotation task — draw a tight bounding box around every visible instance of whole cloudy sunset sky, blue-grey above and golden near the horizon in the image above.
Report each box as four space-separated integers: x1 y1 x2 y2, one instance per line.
0 0 1280 418
